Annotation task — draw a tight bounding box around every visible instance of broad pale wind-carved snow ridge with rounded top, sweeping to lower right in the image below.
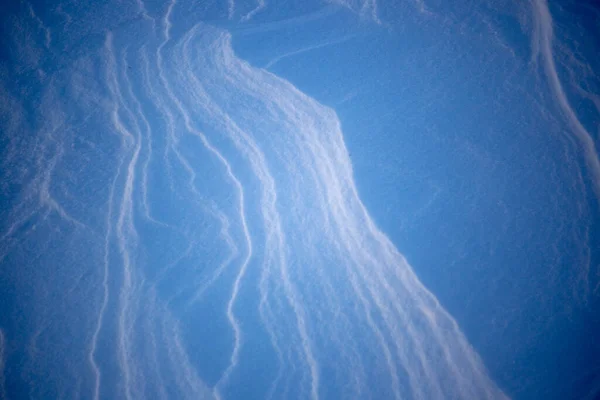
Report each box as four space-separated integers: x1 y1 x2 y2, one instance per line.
152 19 503 399
